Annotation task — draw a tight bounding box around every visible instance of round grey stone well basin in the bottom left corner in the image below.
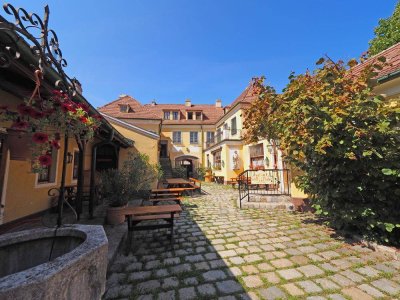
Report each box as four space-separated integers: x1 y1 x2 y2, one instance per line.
0 225 108 300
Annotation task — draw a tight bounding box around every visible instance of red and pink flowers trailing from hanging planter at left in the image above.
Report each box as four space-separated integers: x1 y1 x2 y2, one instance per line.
0 90 101 173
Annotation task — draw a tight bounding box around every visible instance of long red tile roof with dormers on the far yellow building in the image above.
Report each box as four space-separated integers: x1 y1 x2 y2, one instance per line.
98 96 224 124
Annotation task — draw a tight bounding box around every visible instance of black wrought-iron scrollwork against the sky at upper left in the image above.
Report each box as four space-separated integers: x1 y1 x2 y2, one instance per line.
0 3 76 96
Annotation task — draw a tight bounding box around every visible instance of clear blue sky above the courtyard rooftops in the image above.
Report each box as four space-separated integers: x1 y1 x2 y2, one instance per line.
1 0 397 106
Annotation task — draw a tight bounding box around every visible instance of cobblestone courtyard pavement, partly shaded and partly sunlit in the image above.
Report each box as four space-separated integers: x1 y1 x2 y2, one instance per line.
104 185 400 300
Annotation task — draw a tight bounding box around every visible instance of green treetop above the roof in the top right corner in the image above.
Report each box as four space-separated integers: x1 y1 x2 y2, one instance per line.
369 1 400 55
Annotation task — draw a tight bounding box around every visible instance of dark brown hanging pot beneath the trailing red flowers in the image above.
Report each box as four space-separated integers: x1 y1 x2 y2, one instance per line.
7 129 32 160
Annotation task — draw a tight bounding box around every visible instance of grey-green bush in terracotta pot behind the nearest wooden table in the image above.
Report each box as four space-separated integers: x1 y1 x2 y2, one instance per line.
99 152 162 207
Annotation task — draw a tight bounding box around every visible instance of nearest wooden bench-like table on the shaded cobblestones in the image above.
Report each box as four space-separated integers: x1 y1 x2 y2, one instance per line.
124 204 182 243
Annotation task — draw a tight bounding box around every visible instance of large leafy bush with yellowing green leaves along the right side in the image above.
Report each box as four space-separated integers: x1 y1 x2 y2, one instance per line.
245 59 400 245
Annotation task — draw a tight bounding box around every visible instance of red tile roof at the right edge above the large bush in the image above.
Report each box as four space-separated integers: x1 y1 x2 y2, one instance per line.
351 43 400 78
